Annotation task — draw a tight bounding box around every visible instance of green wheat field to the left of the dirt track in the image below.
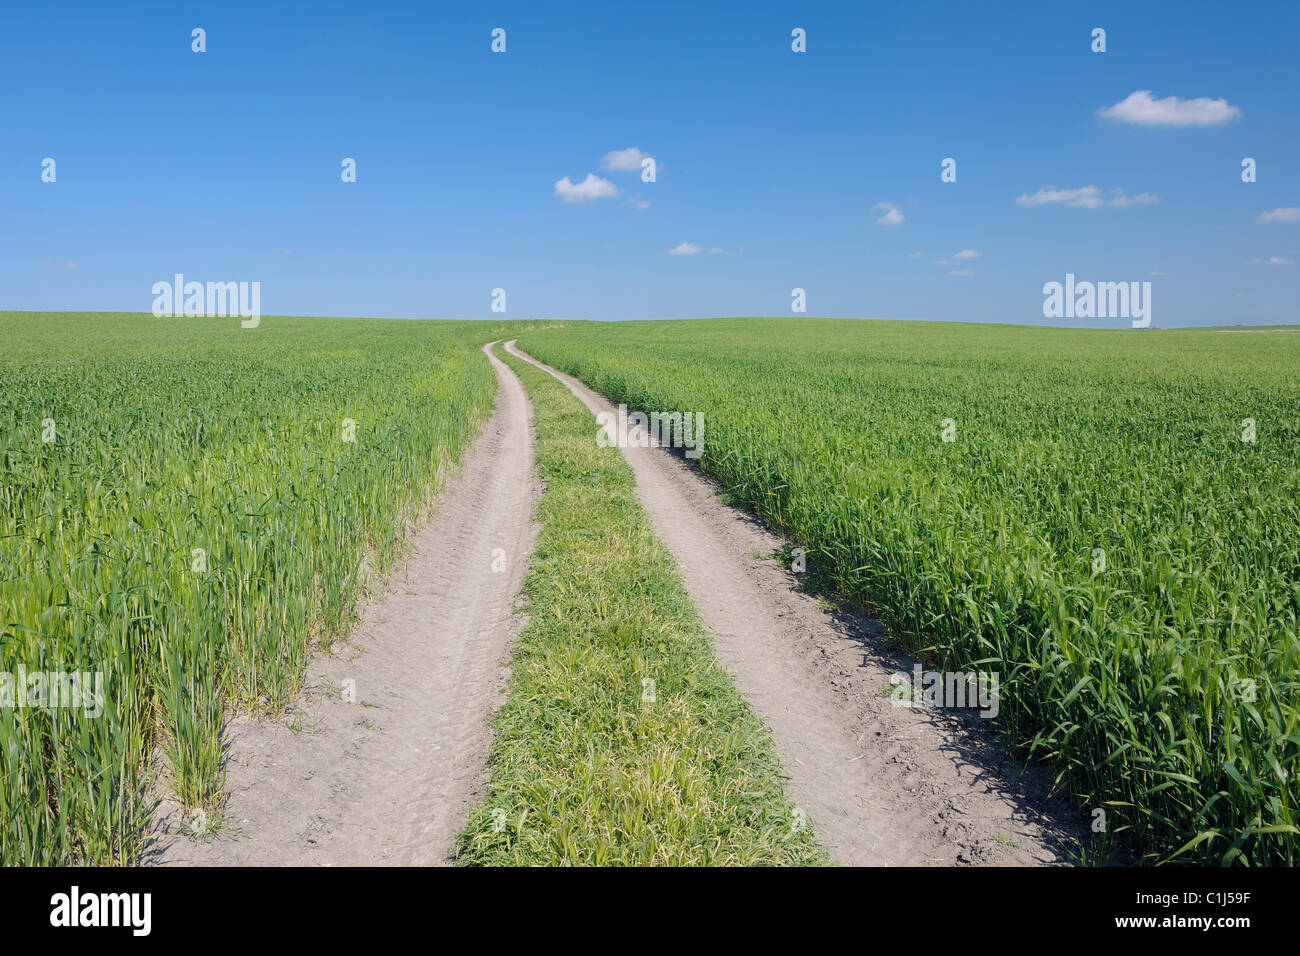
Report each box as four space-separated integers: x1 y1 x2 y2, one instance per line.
0 313 514 864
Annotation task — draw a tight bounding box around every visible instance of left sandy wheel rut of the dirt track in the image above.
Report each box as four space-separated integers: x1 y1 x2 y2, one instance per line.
144 349 540 866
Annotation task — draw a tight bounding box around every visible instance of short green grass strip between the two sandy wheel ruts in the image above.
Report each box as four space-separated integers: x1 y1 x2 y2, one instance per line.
458 346 827 865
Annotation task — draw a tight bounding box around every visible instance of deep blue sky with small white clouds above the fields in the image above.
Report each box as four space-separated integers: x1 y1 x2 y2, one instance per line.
0 0 1300 328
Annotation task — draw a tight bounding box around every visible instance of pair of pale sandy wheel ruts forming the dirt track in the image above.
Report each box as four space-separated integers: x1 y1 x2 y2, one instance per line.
146 342 1074 865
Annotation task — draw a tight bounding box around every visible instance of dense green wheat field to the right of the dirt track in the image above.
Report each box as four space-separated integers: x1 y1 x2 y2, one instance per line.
519 319 1300 865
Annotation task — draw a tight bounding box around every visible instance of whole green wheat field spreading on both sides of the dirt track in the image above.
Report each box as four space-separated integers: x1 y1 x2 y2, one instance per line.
0 312 1300 865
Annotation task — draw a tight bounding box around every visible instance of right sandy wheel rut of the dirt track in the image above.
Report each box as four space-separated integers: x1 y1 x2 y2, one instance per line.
507 342 1082 865
